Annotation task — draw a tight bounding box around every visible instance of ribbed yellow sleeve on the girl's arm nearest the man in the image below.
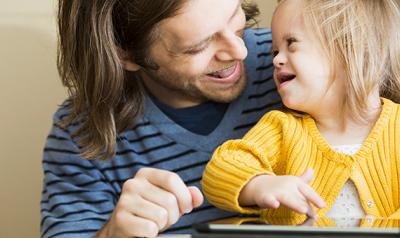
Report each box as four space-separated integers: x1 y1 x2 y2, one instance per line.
202 111 285 213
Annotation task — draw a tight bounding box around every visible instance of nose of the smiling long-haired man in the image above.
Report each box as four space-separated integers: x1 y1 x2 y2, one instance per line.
216 31 247 61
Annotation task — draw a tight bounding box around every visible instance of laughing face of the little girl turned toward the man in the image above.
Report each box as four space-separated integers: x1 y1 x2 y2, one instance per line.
272 0 344 115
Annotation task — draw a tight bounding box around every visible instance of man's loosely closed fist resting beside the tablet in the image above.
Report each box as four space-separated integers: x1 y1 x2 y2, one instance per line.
96 168 203 238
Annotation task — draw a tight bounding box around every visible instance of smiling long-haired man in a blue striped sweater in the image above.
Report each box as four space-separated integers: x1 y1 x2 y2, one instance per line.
41 0 280 237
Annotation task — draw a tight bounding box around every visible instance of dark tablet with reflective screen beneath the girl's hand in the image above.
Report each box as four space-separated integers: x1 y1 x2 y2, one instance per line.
193 217 400 238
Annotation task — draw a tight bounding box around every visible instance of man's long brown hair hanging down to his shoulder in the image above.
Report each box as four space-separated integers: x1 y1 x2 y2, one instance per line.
57 0 259 159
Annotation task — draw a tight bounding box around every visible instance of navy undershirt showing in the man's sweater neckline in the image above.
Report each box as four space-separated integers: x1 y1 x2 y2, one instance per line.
151 97 229 135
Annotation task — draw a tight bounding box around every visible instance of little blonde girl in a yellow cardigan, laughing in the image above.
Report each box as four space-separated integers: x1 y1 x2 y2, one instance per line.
202 0 400 224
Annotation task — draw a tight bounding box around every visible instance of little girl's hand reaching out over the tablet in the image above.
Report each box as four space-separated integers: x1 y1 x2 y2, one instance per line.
239 168 325 217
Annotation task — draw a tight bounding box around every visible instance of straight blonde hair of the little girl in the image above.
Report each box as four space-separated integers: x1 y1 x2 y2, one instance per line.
292 0 400 121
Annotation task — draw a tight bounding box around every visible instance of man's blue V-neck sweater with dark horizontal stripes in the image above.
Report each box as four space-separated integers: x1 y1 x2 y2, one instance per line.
41 29 280 237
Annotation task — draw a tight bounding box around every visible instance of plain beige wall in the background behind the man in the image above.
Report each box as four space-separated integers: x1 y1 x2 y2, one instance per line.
0 0 275 238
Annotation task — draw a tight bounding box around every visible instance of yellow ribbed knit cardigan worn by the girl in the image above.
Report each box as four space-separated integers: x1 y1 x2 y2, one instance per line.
202 98 400 223
